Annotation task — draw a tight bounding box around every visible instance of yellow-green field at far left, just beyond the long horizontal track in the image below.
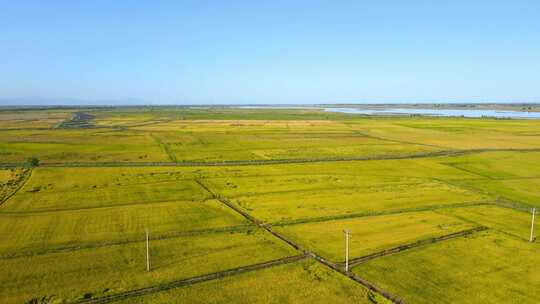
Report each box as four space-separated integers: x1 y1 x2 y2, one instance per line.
0 129 168 164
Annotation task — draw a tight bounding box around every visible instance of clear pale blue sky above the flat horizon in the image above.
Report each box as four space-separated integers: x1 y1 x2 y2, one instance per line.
0 0 540 104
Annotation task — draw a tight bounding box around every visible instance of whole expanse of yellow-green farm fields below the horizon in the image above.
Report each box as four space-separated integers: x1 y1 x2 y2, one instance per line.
0 107 540 303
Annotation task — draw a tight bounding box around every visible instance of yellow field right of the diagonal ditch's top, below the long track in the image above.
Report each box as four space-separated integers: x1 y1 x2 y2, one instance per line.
202 158 484 198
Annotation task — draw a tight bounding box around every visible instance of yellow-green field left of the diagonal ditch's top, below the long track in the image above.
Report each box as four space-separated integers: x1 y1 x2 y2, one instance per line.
3 168 210 212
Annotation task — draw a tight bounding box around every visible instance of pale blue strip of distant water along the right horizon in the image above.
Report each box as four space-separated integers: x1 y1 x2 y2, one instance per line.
324 108 540 119
